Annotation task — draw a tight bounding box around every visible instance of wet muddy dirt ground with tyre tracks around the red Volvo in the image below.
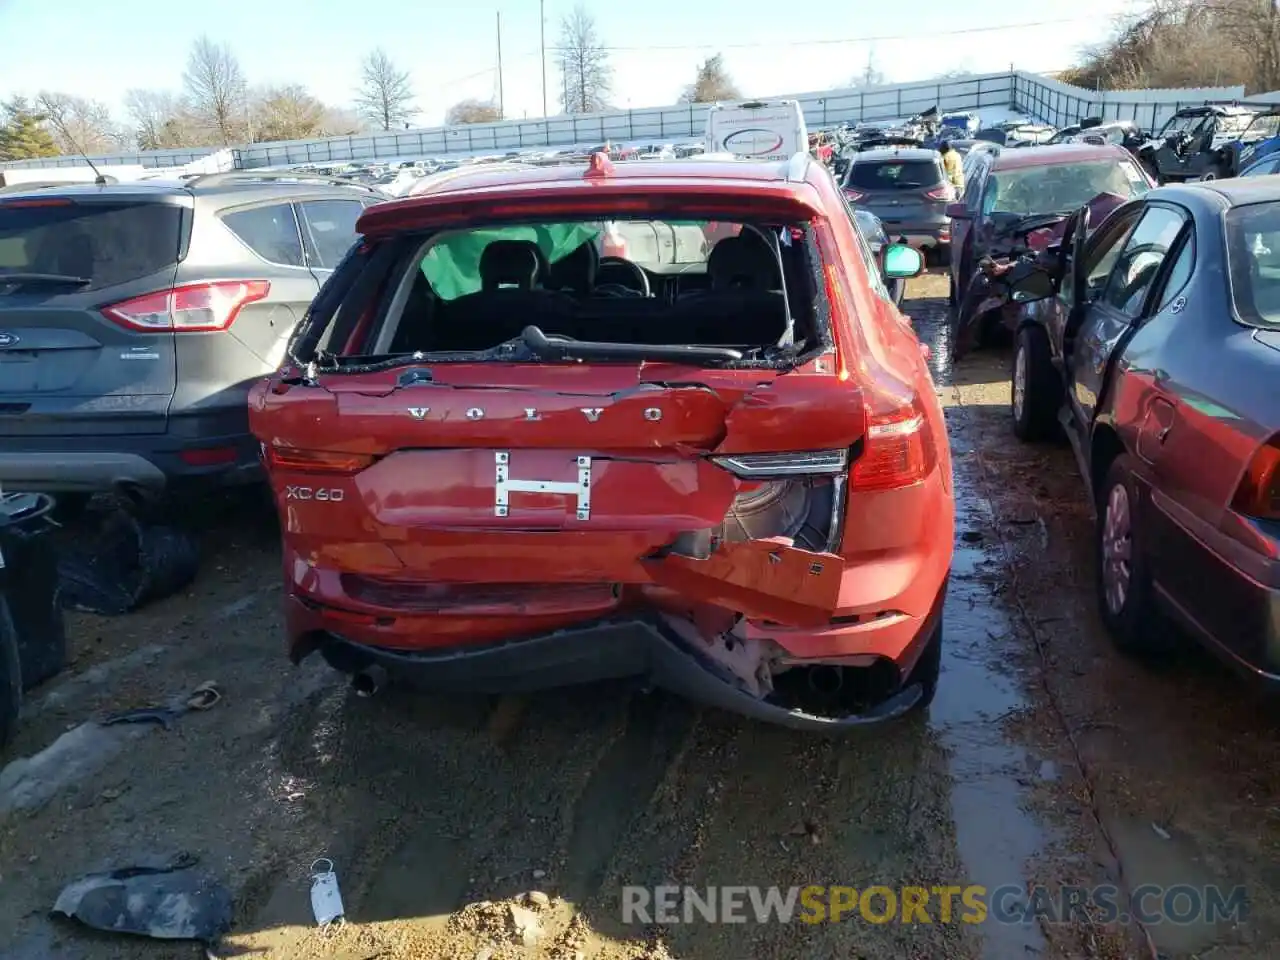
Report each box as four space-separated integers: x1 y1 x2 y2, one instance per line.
0 275 1280 960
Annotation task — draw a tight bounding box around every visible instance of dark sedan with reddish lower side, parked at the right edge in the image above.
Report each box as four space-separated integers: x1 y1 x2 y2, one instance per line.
1011 178 1280 686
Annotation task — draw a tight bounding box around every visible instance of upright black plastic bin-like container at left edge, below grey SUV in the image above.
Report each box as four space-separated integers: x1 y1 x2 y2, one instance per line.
0 494 67 690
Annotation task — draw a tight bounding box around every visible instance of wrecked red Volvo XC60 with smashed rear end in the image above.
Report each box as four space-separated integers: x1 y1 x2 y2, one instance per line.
250 156 954 728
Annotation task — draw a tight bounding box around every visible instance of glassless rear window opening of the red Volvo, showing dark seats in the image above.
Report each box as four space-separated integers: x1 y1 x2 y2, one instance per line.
343 219 827 364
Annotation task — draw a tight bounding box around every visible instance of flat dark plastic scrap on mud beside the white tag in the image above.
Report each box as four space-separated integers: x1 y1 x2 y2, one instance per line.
52 854 232 943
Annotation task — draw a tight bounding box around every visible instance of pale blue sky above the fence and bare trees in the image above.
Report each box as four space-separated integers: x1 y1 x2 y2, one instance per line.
0 0 1139 125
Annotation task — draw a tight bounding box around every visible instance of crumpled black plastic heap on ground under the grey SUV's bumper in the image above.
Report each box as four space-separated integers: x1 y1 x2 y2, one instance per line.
58 509 200 616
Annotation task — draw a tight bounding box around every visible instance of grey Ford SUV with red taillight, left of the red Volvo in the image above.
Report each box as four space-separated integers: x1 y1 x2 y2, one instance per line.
0 173 383 514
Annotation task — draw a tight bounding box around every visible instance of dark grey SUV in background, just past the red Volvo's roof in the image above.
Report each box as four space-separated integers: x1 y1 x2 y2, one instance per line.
841 147 955 257
